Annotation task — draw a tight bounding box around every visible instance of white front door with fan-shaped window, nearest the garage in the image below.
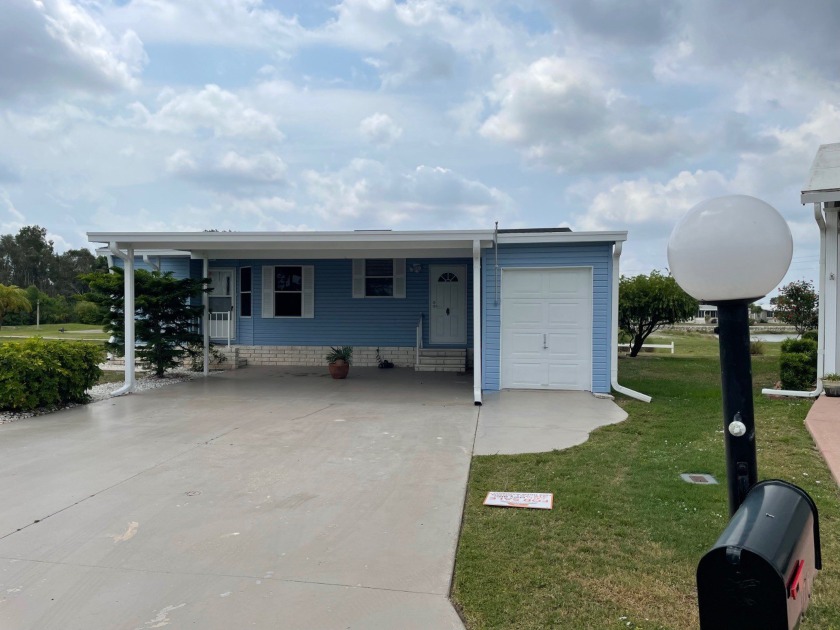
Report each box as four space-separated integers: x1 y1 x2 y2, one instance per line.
429 265 467 344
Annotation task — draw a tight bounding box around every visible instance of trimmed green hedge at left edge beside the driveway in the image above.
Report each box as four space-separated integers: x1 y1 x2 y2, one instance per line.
0 338 105 411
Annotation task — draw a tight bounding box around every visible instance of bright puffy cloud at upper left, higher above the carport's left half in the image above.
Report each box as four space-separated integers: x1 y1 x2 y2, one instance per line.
124 84 283 142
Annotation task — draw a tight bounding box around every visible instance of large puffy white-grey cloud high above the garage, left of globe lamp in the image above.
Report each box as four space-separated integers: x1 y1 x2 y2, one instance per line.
480 57 699 172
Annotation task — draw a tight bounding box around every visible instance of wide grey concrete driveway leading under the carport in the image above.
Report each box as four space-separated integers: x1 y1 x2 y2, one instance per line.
0 368 628 630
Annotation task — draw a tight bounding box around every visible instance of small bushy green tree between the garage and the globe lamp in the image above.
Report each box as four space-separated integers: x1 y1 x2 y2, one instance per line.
618 270 698 357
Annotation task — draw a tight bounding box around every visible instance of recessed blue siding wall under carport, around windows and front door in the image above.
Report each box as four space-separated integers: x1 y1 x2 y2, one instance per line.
193 258 473 347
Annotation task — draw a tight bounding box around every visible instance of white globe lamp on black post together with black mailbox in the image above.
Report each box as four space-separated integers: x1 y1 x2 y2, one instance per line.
668 195 822 630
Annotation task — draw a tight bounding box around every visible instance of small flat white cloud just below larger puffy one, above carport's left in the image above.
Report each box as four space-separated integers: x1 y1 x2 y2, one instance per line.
166 149 286 187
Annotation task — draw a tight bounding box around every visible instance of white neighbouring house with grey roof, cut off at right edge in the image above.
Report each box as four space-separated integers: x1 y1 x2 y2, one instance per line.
801 143 840 378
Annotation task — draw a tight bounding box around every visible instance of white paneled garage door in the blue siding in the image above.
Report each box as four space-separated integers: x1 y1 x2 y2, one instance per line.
501 268 592 390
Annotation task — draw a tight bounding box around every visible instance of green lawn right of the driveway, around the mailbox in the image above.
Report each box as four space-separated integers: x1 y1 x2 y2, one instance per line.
453 333 840 629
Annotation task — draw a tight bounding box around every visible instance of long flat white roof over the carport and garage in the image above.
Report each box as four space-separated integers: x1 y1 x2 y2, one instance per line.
87 228 627 259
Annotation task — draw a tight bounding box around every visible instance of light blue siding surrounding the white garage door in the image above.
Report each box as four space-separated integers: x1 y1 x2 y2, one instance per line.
482 243 614 393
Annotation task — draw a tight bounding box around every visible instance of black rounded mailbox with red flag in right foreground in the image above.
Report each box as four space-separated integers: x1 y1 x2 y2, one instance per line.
697 480 822 630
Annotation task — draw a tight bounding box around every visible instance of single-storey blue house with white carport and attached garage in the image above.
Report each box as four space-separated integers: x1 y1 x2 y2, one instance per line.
88 228 642 404
